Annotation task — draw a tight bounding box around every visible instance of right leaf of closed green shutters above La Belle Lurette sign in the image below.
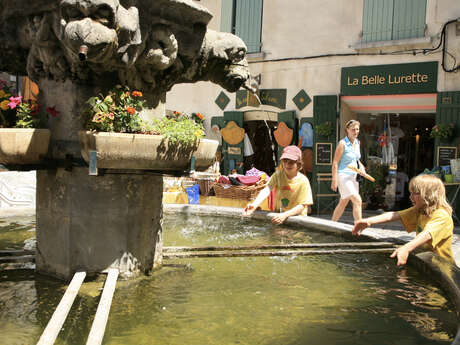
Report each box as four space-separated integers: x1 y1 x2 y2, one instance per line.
392 0 426 40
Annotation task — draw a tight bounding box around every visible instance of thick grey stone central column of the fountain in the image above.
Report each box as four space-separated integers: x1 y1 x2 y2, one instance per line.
36 80 163 280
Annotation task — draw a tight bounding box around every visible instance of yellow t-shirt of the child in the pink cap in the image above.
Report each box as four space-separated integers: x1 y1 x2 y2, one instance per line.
268 169 313 215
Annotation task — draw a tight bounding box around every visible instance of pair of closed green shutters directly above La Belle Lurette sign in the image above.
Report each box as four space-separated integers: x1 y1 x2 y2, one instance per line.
362 0 426 42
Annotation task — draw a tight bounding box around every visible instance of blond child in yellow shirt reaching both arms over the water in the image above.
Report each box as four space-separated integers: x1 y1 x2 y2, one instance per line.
352 175 455 266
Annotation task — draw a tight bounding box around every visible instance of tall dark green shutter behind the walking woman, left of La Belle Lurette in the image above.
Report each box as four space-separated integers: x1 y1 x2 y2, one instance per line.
310 95 337 213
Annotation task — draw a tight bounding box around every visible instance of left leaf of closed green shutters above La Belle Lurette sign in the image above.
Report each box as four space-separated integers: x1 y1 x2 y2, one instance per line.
362 0 393 42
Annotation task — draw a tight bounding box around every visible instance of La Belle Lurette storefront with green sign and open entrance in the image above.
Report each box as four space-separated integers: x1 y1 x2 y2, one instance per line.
338 62 458 210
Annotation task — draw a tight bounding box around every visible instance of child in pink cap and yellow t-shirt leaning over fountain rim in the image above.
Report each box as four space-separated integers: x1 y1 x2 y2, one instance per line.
243 145 313 224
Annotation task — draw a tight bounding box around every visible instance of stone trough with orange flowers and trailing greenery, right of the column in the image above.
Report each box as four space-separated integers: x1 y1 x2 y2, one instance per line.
78 86 218 171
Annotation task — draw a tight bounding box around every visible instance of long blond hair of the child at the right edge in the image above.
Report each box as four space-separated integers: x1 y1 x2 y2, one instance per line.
409 175 452 217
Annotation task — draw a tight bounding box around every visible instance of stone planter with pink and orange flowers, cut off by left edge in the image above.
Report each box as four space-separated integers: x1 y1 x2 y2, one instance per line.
0 80 58 165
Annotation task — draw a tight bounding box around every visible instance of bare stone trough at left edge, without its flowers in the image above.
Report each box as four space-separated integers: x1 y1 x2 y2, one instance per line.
0 128 51 165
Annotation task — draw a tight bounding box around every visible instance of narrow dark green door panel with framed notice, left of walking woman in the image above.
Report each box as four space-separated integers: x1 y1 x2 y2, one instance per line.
310 95 338 213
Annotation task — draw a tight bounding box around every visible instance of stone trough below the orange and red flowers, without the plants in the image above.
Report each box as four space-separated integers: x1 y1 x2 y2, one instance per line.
78 131 219 171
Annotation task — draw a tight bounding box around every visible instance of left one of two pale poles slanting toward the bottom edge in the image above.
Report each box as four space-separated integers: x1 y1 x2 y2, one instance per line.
37 272 86 345
